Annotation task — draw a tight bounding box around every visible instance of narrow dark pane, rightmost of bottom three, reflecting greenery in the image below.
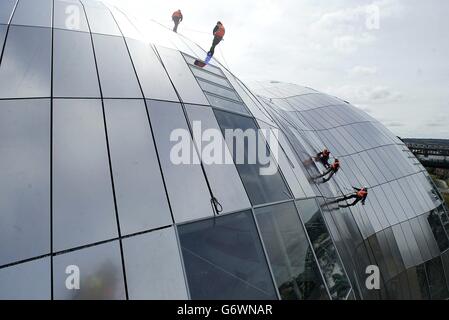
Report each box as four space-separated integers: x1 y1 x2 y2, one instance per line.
296 199 351 299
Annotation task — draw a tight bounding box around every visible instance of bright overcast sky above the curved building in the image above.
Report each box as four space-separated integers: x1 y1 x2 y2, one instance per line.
108 0 449 139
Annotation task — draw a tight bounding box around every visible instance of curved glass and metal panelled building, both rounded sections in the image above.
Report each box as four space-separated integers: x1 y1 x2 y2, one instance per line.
0 0 449 300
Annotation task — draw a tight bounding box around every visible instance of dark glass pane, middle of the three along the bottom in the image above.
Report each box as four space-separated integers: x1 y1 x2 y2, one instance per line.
256 203 329 300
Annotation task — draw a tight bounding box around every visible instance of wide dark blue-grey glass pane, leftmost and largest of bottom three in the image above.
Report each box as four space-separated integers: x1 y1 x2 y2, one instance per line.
179 211 277 300
